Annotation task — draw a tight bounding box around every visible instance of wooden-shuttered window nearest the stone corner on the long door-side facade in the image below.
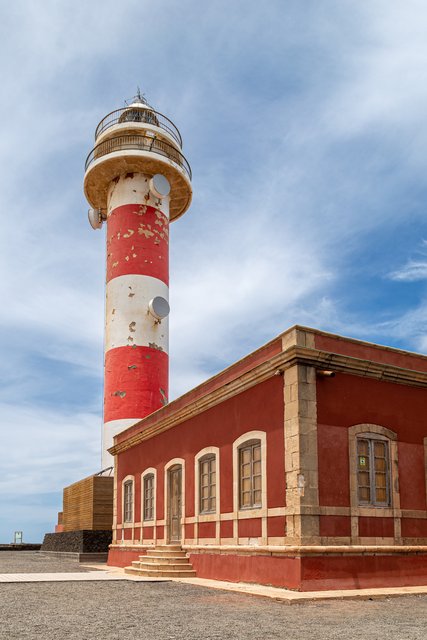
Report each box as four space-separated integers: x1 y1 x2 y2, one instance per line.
238 440 262 509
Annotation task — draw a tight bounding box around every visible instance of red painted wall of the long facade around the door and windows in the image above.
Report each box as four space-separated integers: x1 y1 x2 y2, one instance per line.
117 376 285 523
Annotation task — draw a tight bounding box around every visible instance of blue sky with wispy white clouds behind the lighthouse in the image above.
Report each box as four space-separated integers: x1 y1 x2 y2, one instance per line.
0 0 427 542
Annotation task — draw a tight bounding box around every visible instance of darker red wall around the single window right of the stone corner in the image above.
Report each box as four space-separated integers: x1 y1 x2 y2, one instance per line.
317 372 427 524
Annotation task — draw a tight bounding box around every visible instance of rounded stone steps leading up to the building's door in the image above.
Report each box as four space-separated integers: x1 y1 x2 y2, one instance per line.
125 544 196 578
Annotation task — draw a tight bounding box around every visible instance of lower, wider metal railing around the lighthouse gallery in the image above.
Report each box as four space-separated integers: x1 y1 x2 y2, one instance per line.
85 135 191 180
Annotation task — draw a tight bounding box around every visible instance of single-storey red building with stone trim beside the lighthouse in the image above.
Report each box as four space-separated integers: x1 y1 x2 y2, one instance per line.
109 326 427 590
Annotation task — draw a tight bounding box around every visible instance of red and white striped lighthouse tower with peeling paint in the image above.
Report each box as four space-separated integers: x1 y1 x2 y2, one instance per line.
84 94 192 468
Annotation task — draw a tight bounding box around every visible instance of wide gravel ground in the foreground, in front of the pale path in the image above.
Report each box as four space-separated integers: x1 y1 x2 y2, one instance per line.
0 559 427 640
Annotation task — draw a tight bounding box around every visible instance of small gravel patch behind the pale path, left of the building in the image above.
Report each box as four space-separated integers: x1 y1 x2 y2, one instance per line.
0 551 93 573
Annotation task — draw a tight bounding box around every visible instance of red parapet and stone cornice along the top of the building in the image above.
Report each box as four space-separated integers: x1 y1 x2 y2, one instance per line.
109 325 427 455
